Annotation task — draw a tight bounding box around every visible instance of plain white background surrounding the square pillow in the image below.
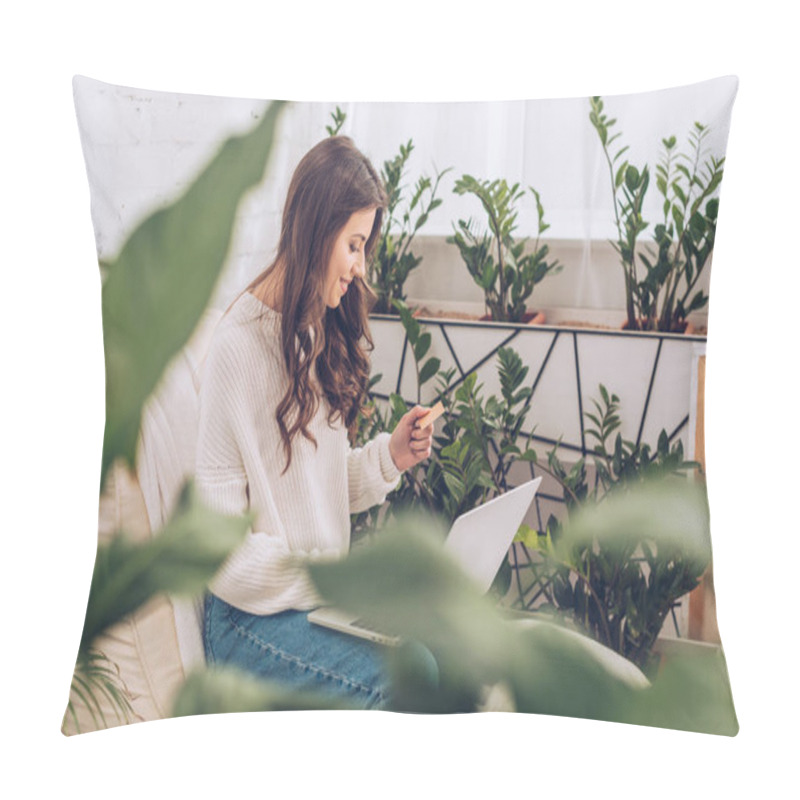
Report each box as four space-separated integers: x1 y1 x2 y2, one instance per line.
0 0 799 798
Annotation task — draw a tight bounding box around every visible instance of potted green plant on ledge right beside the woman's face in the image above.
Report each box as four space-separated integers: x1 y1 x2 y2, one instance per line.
367 139 450 314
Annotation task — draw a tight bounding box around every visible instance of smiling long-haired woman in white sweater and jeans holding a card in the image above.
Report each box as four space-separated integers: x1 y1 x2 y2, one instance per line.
197 137 432 707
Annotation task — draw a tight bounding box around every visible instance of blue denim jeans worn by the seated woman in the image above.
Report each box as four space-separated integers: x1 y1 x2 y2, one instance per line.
203 593 388 708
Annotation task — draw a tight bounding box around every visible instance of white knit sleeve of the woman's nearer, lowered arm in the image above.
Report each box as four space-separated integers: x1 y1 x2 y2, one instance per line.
196 324 307 613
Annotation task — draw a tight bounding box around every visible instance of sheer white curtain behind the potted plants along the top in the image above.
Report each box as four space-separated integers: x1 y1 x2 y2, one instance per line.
345 78 736 239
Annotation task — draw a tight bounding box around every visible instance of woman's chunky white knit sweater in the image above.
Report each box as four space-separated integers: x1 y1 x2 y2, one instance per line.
196 292 400 614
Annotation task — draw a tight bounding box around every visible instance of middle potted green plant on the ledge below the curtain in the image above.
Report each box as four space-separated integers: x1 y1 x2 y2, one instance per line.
447 175 562 322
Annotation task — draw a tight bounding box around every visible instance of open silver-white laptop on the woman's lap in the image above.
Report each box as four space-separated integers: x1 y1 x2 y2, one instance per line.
308 477 542 646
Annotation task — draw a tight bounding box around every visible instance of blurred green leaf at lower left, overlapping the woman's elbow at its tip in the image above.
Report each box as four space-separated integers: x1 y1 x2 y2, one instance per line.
80 484 250 652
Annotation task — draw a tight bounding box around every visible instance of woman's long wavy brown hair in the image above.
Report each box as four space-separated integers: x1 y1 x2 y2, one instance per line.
248 136 387 472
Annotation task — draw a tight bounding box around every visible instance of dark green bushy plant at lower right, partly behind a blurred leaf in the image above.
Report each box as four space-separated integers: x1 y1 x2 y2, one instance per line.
519 385 708 669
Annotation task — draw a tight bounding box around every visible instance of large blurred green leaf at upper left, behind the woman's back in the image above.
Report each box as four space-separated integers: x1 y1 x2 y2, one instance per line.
102 103 283 488
